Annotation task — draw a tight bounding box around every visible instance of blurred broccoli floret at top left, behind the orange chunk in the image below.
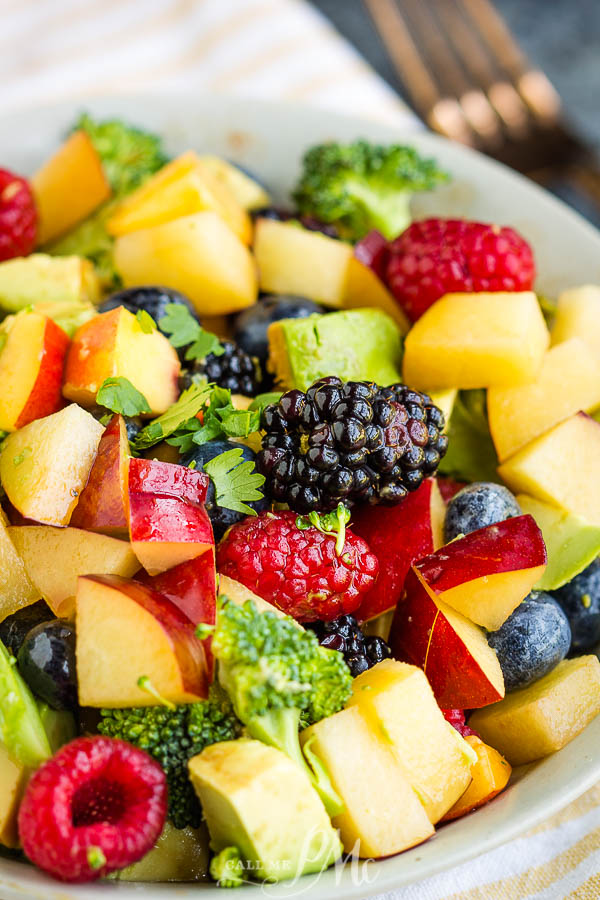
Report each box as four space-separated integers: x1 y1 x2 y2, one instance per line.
74 113 168 197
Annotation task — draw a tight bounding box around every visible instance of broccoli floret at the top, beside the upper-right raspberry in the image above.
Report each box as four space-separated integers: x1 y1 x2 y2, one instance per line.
294 140 447 240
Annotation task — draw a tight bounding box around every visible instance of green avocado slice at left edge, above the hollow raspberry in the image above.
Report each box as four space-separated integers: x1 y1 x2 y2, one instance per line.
0 643 52 769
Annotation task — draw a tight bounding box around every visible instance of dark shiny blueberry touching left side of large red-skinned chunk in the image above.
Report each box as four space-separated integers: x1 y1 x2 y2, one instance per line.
17 619 77 709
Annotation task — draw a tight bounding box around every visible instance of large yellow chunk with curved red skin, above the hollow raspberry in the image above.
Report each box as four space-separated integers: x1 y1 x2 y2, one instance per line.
76 575 208 709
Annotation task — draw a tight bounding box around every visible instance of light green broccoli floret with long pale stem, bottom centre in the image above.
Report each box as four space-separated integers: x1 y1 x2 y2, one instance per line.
212 600 352 815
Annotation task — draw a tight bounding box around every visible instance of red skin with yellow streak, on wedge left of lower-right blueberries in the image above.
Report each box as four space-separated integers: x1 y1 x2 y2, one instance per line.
389 568 502 709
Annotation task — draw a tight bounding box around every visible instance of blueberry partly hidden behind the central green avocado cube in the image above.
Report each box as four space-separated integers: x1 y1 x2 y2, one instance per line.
233 294 325 367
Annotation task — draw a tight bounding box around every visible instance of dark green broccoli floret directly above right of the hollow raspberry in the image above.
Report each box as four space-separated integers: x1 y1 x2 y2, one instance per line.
98 685 241 828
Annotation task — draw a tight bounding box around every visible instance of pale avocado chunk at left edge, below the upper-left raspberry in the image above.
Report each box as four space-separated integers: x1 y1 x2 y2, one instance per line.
0 253 100 318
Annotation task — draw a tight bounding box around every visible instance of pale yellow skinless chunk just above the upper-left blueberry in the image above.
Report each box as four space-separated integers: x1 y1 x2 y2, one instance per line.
114 212 258 316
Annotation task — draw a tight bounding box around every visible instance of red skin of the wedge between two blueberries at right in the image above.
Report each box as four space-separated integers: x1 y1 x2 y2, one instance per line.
416 516 547 599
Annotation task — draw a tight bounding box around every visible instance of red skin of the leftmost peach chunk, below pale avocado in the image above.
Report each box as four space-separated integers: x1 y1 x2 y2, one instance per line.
15 319 69 428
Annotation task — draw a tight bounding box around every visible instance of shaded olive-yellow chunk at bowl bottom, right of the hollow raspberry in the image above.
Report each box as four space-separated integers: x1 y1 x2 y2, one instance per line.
111 822 209 882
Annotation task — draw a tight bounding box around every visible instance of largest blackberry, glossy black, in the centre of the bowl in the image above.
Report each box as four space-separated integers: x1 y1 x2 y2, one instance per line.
256 376 448 513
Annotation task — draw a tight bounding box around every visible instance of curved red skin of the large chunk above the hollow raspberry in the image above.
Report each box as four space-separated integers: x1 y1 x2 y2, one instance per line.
85 575 209 697
